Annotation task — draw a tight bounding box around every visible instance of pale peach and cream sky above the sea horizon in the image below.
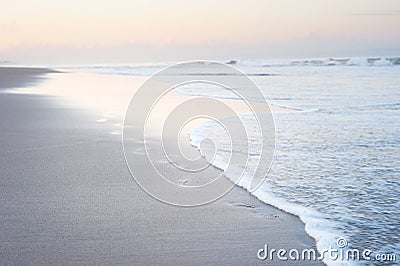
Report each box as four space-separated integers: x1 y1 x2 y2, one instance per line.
0 0 400 64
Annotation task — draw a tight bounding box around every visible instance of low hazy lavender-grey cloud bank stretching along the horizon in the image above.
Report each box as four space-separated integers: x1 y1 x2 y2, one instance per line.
0 35 400 65
